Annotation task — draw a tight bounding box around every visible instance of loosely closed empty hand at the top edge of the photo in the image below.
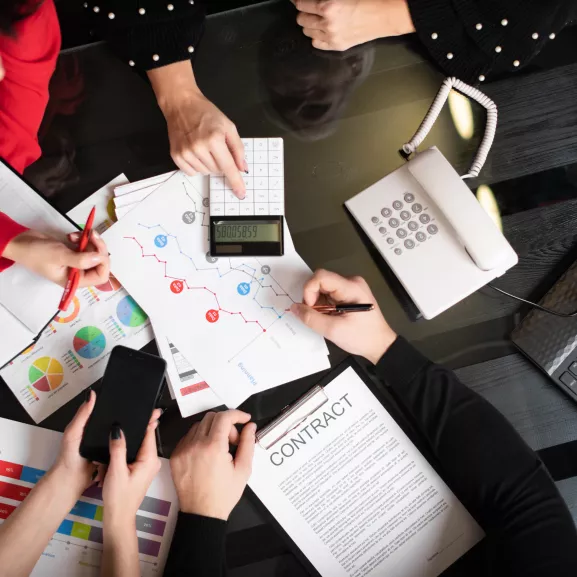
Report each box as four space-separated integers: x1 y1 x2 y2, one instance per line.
291 0 415 51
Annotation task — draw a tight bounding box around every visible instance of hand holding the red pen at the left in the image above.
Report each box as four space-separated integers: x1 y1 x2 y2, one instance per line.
2 230 110 287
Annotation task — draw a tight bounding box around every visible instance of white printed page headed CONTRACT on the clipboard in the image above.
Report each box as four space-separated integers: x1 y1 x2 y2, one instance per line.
249 368 484 577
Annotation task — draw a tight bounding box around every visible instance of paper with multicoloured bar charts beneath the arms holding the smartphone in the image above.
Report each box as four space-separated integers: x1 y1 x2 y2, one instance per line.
0 418 178 577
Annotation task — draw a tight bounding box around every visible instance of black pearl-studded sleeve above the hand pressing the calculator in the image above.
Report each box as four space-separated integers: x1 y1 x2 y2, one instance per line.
83 0 205 70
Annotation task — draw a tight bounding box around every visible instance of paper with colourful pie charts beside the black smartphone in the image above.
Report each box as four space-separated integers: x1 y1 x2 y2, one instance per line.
0 177 154 423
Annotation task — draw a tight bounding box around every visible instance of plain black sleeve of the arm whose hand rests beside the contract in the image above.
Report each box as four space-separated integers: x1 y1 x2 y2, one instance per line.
164 512 226 577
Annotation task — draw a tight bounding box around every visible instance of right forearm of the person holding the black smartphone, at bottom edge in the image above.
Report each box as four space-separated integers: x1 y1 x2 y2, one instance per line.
101 507 140 577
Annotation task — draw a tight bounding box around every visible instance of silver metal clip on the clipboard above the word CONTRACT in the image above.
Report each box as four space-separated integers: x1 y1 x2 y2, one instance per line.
256 385 329 450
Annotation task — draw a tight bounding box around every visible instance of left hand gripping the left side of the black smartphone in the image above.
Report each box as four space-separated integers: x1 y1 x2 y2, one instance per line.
50 391 100 500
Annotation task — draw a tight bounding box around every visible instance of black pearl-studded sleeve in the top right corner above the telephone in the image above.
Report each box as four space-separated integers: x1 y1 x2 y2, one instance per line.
408 0 577 83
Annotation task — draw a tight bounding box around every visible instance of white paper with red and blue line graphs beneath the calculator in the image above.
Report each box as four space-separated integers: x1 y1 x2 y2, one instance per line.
104 172 330 407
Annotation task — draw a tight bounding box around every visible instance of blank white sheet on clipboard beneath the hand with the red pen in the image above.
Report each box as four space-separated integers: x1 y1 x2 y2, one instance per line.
0 163 76 342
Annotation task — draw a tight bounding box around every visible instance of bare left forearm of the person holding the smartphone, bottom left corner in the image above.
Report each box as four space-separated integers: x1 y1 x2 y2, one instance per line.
0 470 81 577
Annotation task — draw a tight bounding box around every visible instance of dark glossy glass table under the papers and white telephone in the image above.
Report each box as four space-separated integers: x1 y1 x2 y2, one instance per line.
0 2 577 577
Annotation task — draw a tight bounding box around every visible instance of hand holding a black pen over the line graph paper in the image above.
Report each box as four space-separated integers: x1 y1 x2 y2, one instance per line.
291 269 397 365
